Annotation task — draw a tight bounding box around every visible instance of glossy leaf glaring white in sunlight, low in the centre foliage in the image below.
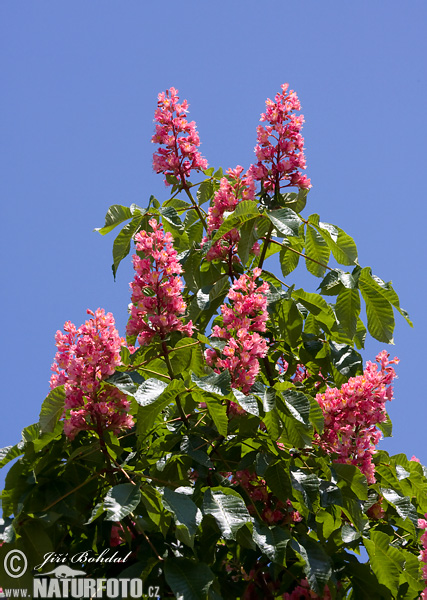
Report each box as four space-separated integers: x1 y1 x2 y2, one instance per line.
203 487 252 540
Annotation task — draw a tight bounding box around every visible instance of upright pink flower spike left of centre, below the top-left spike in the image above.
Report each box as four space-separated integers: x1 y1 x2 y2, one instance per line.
126 219 193 346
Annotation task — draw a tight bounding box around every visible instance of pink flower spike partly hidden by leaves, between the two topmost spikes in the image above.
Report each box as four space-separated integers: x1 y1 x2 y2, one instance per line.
203 165 259 261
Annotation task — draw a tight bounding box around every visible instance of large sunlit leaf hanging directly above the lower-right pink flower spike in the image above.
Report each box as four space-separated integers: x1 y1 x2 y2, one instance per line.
359 267 394 344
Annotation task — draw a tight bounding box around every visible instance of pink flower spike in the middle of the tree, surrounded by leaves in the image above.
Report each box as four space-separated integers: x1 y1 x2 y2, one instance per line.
205 269 269 394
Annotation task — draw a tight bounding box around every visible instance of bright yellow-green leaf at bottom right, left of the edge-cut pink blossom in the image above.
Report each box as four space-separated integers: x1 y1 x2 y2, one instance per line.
363 530 405 597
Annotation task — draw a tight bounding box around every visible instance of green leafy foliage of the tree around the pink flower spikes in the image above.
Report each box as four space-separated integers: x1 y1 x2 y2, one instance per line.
0 119 427 600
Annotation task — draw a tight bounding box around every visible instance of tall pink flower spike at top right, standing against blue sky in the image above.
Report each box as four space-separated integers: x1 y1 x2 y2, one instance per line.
249 83 311 192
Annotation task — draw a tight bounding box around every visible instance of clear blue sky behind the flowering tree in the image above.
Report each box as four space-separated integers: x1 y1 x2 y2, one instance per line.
0 0 427 488
